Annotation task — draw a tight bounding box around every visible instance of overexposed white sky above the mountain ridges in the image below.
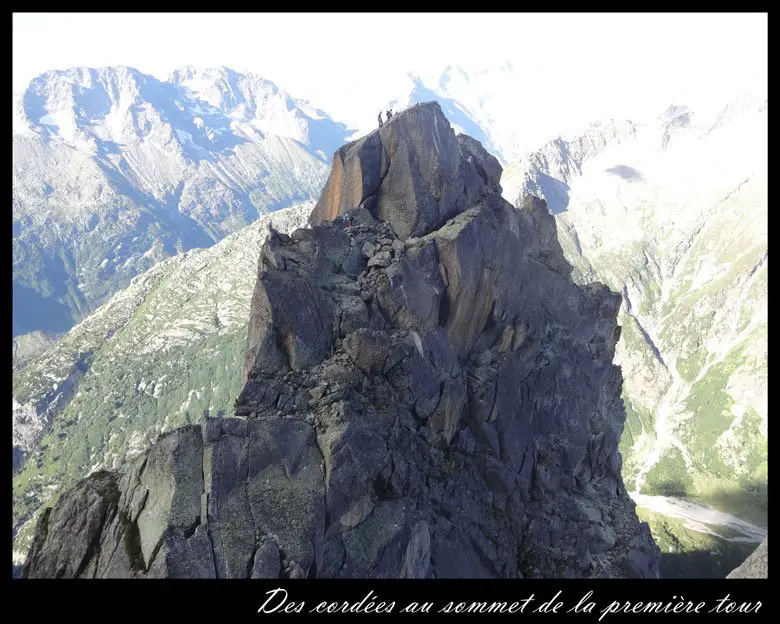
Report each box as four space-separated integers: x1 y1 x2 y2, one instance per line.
13 13 768 149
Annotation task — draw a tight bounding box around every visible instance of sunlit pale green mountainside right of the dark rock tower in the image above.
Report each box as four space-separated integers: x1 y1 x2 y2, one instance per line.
507 85 768 572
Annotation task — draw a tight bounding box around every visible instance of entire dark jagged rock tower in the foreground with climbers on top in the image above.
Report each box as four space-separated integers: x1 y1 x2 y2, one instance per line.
23 104 659 578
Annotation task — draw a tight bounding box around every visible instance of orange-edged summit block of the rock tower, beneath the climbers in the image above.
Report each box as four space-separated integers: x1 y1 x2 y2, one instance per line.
309 103 501 239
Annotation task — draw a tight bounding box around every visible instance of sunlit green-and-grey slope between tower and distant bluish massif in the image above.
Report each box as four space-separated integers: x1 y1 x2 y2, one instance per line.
13 203 313 557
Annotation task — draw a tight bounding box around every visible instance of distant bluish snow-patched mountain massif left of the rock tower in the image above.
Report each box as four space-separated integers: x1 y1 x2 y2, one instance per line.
13 67 347 335
